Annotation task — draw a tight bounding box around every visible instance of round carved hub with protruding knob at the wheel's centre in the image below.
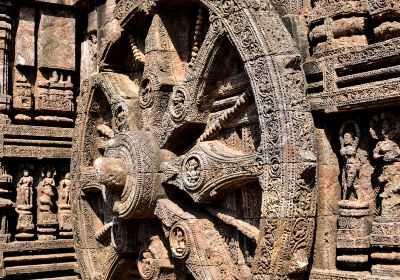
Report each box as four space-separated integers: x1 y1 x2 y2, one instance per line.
94 131 163 219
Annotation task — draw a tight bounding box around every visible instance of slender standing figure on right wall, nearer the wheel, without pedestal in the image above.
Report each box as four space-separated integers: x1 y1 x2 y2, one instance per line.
340 121 361 200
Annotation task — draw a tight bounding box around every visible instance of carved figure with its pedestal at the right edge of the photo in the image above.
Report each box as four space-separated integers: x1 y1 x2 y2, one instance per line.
370 112 400 276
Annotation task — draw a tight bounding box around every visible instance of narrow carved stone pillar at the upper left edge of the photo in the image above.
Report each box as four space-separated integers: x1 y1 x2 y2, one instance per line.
0 0 12 118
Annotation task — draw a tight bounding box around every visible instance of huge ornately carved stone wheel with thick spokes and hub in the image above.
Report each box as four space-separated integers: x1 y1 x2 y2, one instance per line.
72 0 316 279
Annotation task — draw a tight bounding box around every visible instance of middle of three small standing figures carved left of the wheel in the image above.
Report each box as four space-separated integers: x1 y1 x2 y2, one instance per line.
38 170 56 212
